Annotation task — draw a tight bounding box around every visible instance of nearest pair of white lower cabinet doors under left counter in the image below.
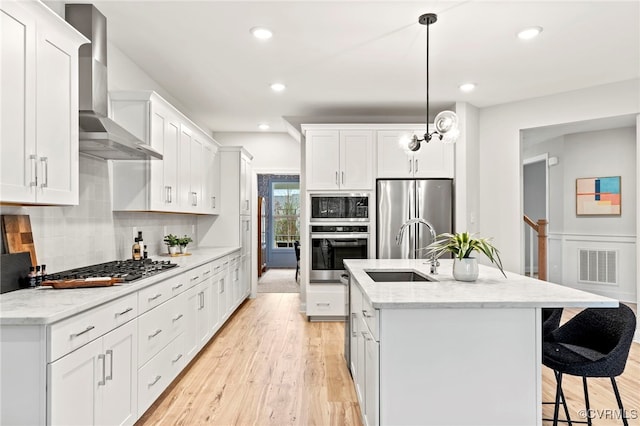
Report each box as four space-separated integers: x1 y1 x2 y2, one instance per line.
48 320 138 425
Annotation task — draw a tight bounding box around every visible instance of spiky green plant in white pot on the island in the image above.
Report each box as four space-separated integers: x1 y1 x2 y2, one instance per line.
426 232 507 281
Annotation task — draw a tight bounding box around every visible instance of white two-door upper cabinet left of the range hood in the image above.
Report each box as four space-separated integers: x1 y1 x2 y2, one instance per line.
0 1 88 205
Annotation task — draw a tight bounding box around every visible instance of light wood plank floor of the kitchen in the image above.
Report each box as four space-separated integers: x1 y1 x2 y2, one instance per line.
137 293 640 426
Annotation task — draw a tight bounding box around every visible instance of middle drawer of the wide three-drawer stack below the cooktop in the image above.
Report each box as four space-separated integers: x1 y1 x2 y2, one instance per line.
138 297 186 365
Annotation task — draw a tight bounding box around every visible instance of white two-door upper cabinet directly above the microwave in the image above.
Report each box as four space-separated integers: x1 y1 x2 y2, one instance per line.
305 129 374 190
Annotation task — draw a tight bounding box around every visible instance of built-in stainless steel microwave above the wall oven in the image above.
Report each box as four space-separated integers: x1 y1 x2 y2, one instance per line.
311 194 369 222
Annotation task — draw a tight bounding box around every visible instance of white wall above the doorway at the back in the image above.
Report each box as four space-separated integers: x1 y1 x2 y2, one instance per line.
213 132 300 174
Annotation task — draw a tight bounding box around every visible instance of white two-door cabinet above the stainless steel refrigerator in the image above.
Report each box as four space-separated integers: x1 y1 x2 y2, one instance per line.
377 128 454 178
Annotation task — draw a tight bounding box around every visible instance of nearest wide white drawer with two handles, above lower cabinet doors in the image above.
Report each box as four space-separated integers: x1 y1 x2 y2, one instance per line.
48 294 138 362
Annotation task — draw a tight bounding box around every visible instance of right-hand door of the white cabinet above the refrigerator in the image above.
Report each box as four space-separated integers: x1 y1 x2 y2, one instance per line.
413 138 454 178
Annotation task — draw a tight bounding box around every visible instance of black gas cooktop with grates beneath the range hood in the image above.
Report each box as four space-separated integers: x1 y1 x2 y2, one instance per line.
46 259 178 282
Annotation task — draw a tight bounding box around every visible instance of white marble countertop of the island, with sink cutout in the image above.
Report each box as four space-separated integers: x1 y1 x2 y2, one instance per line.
344 259 618 309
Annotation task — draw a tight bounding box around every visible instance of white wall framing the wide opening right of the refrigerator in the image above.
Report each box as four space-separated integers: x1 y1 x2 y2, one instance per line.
478 80 640 272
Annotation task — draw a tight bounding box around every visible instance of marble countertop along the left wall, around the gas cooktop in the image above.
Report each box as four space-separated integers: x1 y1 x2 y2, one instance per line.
0 247 240 325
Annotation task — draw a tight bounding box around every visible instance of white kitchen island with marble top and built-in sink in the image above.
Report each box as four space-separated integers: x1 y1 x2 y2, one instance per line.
344 259 618 426
